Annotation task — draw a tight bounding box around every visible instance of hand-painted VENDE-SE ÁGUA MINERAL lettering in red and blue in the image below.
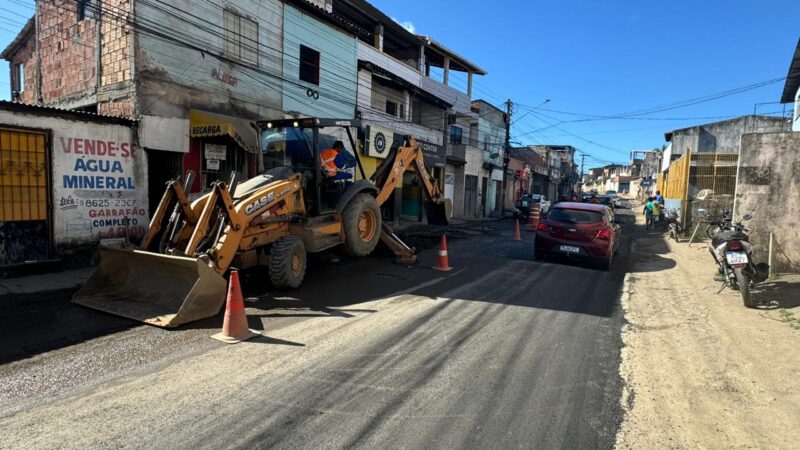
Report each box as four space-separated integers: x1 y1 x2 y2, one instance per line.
53 133 148 245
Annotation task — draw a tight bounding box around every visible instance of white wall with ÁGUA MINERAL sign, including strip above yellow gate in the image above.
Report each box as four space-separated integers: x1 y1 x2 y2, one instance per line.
0 107 149 253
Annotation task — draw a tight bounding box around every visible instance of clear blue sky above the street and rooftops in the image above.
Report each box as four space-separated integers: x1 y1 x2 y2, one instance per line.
0 0 800 166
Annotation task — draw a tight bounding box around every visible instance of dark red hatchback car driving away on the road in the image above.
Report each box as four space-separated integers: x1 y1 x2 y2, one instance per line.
534 202 621 270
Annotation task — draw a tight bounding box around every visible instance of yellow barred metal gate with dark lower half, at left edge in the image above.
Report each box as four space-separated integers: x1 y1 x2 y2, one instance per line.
0 127 50 265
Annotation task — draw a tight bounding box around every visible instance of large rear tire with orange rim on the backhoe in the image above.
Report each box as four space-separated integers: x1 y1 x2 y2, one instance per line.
342 193 381 256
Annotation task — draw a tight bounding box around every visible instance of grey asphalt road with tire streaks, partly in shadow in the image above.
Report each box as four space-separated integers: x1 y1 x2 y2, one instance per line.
0 208 632 448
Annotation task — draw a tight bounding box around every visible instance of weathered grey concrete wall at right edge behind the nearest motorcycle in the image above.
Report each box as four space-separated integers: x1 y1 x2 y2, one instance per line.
735 133 800 272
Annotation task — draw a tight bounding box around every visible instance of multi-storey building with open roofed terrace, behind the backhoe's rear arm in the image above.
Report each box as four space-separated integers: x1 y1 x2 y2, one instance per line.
350 7 486 221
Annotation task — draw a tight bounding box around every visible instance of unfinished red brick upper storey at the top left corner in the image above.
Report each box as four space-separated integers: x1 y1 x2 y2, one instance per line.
0 0 135 116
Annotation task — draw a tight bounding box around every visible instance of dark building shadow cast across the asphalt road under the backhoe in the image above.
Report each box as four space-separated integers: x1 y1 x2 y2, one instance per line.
0 216 633 364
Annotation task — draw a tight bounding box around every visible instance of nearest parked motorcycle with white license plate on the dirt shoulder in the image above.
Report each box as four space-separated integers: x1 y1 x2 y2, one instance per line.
706 212 769 308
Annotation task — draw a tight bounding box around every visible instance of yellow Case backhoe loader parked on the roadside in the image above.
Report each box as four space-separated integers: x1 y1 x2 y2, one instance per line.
73 118 449 328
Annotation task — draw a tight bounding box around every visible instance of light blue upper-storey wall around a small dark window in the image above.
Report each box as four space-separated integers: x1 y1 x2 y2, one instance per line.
283 6 358 119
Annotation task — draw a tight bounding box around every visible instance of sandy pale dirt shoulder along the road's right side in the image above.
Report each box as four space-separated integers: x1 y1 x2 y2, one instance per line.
617 209 800 449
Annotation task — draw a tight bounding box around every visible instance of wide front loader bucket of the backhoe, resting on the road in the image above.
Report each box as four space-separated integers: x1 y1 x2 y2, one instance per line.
72 247 226 328
